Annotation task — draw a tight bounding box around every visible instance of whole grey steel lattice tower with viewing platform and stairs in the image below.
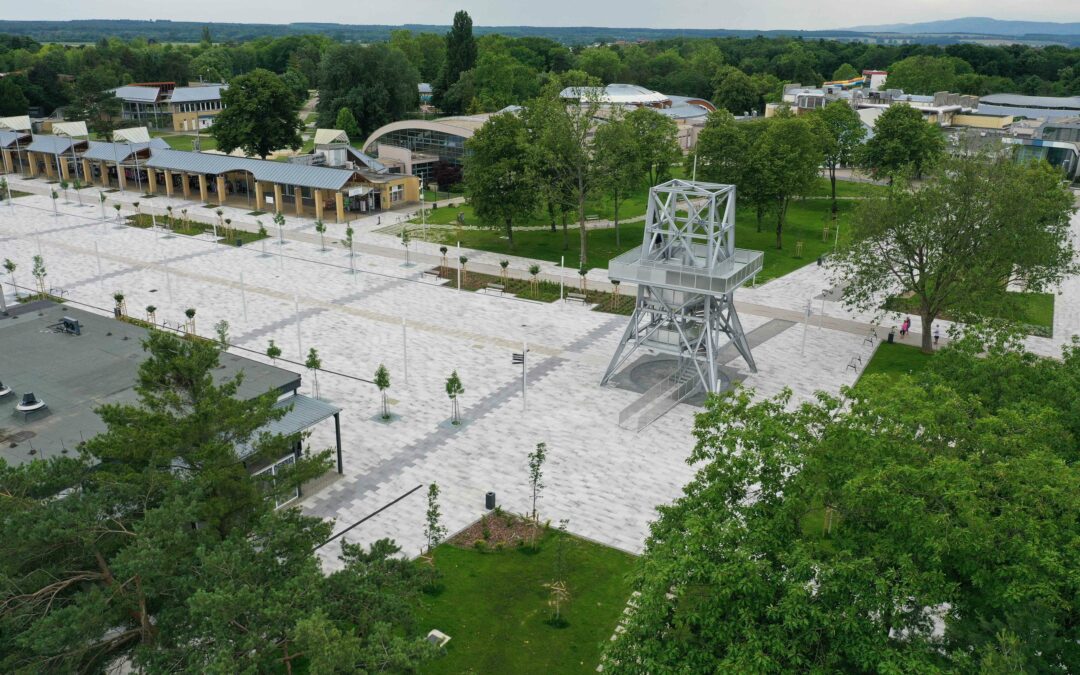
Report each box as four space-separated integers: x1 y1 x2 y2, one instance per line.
600 179 764 397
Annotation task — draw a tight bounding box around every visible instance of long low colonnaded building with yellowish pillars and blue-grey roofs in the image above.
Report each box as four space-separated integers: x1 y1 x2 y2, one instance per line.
0 117 420 222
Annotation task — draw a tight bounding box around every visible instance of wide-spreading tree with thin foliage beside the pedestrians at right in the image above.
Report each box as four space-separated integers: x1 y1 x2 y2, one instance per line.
835 157 1077 353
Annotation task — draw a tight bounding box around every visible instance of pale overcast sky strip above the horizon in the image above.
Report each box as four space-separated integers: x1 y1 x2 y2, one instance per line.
8 0 1080 29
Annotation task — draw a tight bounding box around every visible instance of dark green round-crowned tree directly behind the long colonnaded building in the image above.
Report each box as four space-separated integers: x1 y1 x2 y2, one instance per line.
211 68 303 159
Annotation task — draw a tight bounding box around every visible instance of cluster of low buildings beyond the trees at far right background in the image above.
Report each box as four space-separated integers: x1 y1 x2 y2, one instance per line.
766 70 1080 180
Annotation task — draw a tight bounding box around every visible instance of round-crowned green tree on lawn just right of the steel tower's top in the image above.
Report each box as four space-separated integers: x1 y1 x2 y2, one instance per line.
752 116 822 248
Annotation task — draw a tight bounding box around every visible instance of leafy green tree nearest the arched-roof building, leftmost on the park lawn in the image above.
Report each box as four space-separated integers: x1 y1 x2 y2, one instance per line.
464 112 538 246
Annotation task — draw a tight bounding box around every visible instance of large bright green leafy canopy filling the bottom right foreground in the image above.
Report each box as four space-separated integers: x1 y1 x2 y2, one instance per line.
604 332 1080 673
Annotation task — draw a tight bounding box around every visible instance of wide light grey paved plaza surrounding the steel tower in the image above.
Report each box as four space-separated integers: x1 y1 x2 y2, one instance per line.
0 195 1080 568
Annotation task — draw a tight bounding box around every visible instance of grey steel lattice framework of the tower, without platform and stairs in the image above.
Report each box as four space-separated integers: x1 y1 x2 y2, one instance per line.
600 179 757 393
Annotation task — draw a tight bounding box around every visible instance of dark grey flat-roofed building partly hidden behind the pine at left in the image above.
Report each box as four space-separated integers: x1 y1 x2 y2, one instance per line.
0 301 342 492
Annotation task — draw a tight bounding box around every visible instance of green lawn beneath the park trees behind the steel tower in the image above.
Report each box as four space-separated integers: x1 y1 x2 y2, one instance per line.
414 200 854 283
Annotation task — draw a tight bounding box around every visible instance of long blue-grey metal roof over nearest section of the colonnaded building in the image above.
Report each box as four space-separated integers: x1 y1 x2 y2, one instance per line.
146 149 353 190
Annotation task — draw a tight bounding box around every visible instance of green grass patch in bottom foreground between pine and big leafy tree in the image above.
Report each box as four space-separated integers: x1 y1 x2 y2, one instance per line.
419 531 633 674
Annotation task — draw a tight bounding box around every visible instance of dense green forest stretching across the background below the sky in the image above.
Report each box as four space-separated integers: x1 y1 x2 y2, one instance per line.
0 22 1080 123
